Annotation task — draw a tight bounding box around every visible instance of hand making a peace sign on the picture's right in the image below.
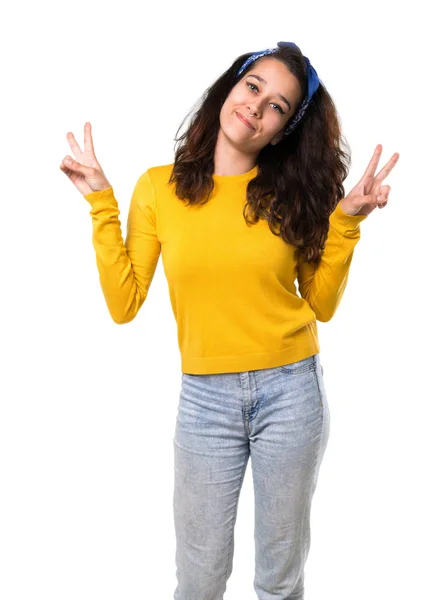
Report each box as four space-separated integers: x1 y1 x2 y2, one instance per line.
339 144 400 216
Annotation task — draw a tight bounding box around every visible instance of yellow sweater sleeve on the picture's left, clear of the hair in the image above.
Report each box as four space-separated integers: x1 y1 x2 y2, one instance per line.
84 171 160 323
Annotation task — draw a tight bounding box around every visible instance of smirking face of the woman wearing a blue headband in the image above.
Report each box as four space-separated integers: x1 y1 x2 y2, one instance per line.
220 57 301 153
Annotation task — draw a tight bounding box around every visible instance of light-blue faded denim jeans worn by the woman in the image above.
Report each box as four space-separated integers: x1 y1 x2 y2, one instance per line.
173 354 330 600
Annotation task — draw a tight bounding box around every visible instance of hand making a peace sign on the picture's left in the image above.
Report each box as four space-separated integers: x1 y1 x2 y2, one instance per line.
59 123 110 196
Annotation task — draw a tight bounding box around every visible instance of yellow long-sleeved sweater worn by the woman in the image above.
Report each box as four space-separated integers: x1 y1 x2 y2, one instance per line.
84 164 366 374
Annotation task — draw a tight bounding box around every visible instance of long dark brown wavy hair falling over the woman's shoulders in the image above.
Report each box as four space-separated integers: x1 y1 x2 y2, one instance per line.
169 47 351 264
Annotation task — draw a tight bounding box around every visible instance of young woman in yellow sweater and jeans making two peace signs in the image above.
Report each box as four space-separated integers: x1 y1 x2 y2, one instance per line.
60 42 399 600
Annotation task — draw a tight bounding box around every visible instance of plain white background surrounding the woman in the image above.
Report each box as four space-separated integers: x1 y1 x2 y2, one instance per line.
0 0 448 600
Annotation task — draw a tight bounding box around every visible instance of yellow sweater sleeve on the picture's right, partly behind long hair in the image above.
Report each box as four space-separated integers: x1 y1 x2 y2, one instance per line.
297 203 367 322
